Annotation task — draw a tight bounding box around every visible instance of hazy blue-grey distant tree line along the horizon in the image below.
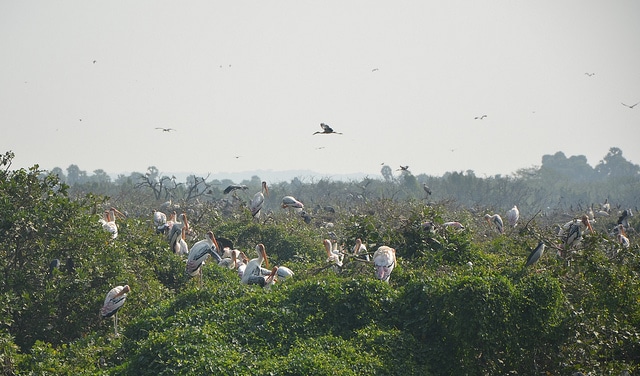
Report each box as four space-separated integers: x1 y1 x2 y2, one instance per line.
42 147 640 219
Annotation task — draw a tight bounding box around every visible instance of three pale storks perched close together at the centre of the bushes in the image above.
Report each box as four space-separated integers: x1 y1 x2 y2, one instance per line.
322 239 396 283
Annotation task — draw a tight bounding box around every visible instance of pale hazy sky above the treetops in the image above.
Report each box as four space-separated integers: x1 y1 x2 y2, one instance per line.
0 0 640 181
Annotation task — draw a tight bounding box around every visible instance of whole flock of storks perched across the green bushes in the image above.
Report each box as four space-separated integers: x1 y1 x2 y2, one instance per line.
95 191 633 335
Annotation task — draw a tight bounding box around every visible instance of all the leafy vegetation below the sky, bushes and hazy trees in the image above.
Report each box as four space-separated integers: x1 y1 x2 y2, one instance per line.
0 148 640 375
